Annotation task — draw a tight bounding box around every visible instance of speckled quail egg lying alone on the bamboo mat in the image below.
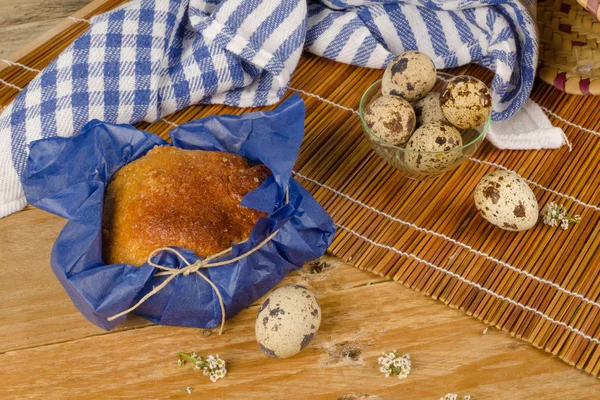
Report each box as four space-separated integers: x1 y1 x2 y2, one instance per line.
475 171 539 231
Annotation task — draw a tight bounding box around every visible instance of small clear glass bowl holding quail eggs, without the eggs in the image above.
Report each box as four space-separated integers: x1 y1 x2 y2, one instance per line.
360 72 491 180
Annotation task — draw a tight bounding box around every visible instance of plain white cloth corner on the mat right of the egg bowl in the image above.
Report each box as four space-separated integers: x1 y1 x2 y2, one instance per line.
487 99 570 150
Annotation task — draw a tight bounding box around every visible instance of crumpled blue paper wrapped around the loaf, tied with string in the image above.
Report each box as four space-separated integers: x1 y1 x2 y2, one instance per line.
22 95 335 330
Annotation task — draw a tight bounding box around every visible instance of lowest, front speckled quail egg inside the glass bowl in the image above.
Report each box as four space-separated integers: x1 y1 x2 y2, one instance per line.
404 122 462 173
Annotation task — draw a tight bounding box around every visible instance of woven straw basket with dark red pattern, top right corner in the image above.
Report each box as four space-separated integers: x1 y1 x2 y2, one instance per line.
537 0 600 95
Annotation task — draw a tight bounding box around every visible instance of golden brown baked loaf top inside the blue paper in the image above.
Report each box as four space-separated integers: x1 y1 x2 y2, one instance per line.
102 146 270 265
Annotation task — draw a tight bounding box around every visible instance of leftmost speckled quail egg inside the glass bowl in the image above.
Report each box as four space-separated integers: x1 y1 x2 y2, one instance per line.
363 96 416 146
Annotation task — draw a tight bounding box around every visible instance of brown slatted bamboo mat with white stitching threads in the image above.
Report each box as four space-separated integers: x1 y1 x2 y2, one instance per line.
0 0 600 376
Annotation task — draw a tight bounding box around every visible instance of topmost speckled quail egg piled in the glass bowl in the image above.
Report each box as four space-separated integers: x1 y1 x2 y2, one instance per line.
381 51 437 101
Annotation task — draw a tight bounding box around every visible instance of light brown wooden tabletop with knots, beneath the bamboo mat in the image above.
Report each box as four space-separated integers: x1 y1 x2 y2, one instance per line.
0 0 600 400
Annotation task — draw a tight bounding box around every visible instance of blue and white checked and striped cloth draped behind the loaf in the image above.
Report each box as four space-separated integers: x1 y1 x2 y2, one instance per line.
0 0 537 217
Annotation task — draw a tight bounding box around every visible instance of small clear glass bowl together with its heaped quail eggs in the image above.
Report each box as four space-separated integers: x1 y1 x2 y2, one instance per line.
360 51 492 180
